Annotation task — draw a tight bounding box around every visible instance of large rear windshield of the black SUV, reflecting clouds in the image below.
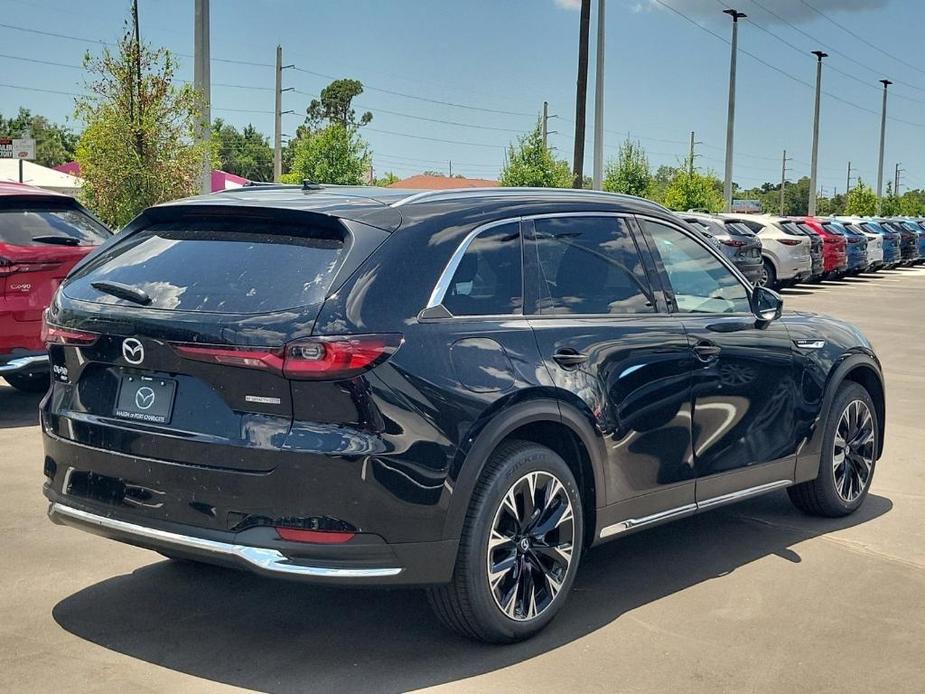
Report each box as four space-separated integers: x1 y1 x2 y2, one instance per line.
65 219 345 313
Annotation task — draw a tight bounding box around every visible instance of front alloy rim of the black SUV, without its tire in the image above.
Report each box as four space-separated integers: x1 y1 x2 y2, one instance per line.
832 400 876 503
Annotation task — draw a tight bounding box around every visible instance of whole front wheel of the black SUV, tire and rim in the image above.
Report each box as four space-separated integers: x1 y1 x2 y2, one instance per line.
787 381 880 518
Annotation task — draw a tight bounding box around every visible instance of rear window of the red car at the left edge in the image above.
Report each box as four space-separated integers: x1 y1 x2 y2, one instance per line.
0 207 110 246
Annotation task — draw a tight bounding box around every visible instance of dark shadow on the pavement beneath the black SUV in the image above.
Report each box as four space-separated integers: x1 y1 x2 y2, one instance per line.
53 493 892 692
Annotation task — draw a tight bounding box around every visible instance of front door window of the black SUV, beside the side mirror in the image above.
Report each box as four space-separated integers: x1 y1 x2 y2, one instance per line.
642 220 751 313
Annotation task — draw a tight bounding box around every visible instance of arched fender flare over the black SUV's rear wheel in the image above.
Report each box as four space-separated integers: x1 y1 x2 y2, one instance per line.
443 397 606 539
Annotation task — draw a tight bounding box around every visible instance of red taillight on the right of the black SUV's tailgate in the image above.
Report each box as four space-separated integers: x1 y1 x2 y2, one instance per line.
173 334 402 380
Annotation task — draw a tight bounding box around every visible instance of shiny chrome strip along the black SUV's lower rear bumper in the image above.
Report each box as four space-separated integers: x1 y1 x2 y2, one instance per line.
48 502 402 578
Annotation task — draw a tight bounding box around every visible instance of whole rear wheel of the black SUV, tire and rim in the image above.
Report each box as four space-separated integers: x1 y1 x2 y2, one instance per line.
427 441 584 643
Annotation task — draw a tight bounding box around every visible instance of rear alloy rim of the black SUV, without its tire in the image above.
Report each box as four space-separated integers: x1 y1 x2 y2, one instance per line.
487 471 575 621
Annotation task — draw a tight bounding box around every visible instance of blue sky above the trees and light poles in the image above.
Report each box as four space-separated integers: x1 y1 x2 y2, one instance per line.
0 0 925 194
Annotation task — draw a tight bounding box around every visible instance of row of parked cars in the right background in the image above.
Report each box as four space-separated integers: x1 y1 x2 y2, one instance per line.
679 212 925 288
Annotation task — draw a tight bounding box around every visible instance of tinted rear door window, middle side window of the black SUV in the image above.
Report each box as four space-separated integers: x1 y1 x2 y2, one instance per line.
530 217 655 315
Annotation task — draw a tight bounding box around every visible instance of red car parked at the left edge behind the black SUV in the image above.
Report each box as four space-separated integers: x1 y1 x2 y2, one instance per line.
0 182 112 392
